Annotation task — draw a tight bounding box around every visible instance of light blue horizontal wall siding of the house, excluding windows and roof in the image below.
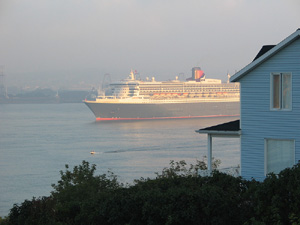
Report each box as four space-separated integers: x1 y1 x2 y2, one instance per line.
239 39 300 180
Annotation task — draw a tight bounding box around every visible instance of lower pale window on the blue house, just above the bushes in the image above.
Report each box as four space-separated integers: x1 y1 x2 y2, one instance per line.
265 139 295 174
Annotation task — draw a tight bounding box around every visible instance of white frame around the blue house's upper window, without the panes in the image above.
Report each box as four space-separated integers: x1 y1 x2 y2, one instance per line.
270 72 293 111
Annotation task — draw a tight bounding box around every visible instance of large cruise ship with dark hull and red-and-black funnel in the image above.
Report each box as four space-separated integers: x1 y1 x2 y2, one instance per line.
84 67 240 121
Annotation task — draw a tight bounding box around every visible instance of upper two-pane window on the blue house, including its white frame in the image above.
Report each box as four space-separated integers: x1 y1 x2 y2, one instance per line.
270 73 292 110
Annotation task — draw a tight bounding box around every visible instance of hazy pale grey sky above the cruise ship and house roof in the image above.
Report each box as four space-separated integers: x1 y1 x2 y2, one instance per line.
0 0 300 86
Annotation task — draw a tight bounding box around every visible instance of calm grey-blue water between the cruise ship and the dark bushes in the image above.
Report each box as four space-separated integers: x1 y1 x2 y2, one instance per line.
0 104 240 216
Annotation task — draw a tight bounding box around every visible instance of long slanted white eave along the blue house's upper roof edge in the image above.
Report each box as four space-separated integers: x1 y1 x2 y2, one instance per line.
230 29 300 82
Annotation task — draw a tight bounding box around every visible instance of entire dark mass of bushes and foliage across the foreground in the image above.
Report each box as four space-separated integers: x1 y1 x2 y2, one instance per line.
0 160 300 225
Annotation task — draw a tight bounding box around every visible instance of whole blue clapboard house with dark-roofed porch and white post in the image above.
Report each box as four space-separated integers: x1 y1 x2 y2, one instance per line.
197 29 300 180
